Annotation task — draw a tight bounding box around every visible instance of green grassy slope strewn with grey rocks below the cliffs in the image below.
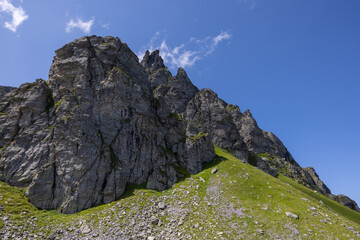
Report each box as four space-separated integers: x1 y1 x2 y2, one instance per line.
0 147 360 239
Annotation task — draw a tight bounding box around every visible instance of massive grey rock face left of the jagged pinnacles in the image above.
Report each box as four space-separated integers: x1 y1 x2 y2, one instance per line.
0 36 214 213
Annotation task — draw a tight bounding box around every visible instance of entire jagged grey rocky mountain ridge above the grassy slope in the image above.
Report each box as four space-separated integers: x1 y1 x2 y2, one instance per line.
0 36 359 213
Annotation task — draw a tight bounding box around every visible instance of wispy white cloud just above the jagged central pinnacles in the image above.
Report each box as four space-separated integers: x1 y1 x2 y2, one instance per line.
138 32 231 68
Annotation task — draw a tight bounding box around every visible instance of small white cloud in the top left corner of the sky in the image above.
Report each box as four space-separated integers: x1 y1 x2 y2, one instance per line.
0 0 29 32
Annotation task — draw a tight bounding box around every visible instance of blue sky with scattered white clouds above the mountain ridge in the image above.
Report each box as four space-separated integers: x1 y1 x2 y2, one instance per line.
0 0 360 203
